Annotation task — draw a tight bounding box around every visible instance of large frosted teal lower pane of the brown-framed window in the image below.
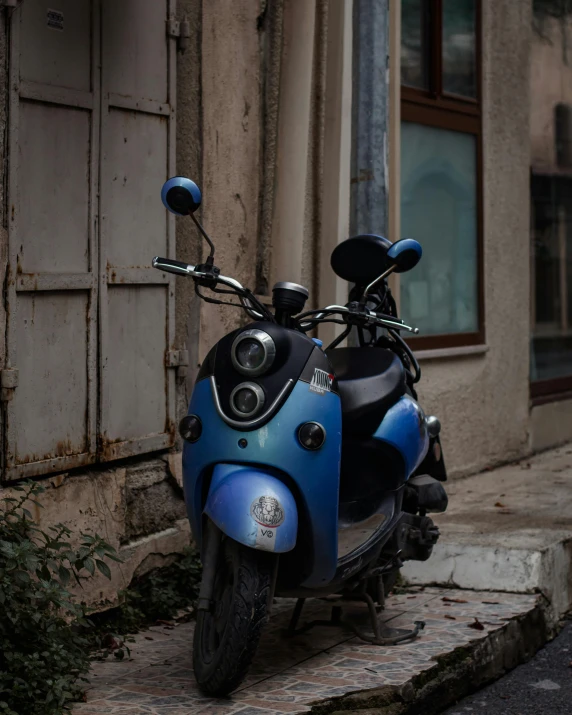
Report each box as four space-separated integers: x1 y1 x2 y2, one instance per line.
400 122 478 335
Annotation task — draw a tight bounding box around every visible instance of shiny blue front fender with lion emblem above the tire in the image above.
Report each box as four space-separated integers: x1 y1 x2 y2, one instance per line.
204 464 298 553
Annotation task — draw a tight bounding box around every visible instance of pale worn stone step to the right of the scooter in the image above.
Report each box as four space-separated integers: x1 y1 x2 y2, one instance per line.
403 445 572 616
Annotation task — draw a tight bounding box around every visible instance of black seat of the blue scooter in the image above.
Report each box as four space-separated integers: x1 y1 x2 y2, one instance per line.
326 348 406 436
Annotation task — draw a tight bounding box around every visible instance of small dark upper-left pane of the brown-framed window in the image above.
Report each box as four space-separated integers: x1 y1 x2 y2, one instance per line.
401 0 429 89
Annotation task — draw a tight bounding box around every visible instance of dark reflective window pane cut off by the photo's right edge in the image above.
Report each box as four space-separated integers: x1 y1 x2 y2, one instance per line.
530 3 572 380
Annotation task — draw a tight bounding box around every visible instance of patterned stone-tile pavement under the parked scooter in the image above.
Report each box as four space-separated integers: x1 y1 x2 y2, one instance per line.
74 588 536 715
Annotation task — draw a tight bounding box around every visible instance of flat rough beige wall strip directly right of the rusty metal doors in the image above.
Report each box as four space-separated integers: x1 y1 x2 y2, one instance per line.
196 0 262 358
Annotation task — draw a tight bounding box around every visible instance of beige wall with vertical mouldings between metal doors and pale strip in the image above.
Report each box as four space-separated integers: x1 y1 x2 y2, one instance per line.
199 0 328 361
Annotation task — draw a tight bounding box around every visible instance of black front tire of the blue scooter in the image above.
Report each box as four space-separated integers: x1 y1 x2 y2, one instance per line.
193 538 274 697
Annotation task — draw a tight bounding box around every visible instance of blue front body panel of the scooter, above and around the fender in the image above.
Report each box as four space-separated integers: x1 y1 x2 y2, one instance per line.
183 378 342 587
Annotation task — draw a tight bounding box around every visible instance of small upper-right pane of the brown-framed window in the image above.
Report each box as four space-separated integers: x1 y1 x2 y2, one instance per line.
443 0 477 97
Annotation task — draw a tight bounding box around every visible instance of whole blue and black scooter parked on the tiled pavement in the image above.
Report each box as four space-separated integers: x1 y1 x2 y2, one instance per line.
153 177 447 696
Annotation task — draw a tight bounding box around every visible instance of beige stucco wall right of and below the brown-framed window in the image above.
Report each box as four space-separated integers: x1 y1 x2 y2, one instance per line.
414 0 531 482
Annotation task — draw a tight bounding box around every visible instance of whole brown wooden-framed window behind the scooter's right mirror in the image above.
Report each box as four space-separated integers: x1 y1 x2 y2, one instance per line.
400 0 485 349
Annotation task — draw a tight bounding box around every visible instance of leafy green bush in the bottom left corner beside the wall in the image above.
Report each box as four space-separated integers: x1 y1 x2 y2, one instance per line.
0 482 120 715
